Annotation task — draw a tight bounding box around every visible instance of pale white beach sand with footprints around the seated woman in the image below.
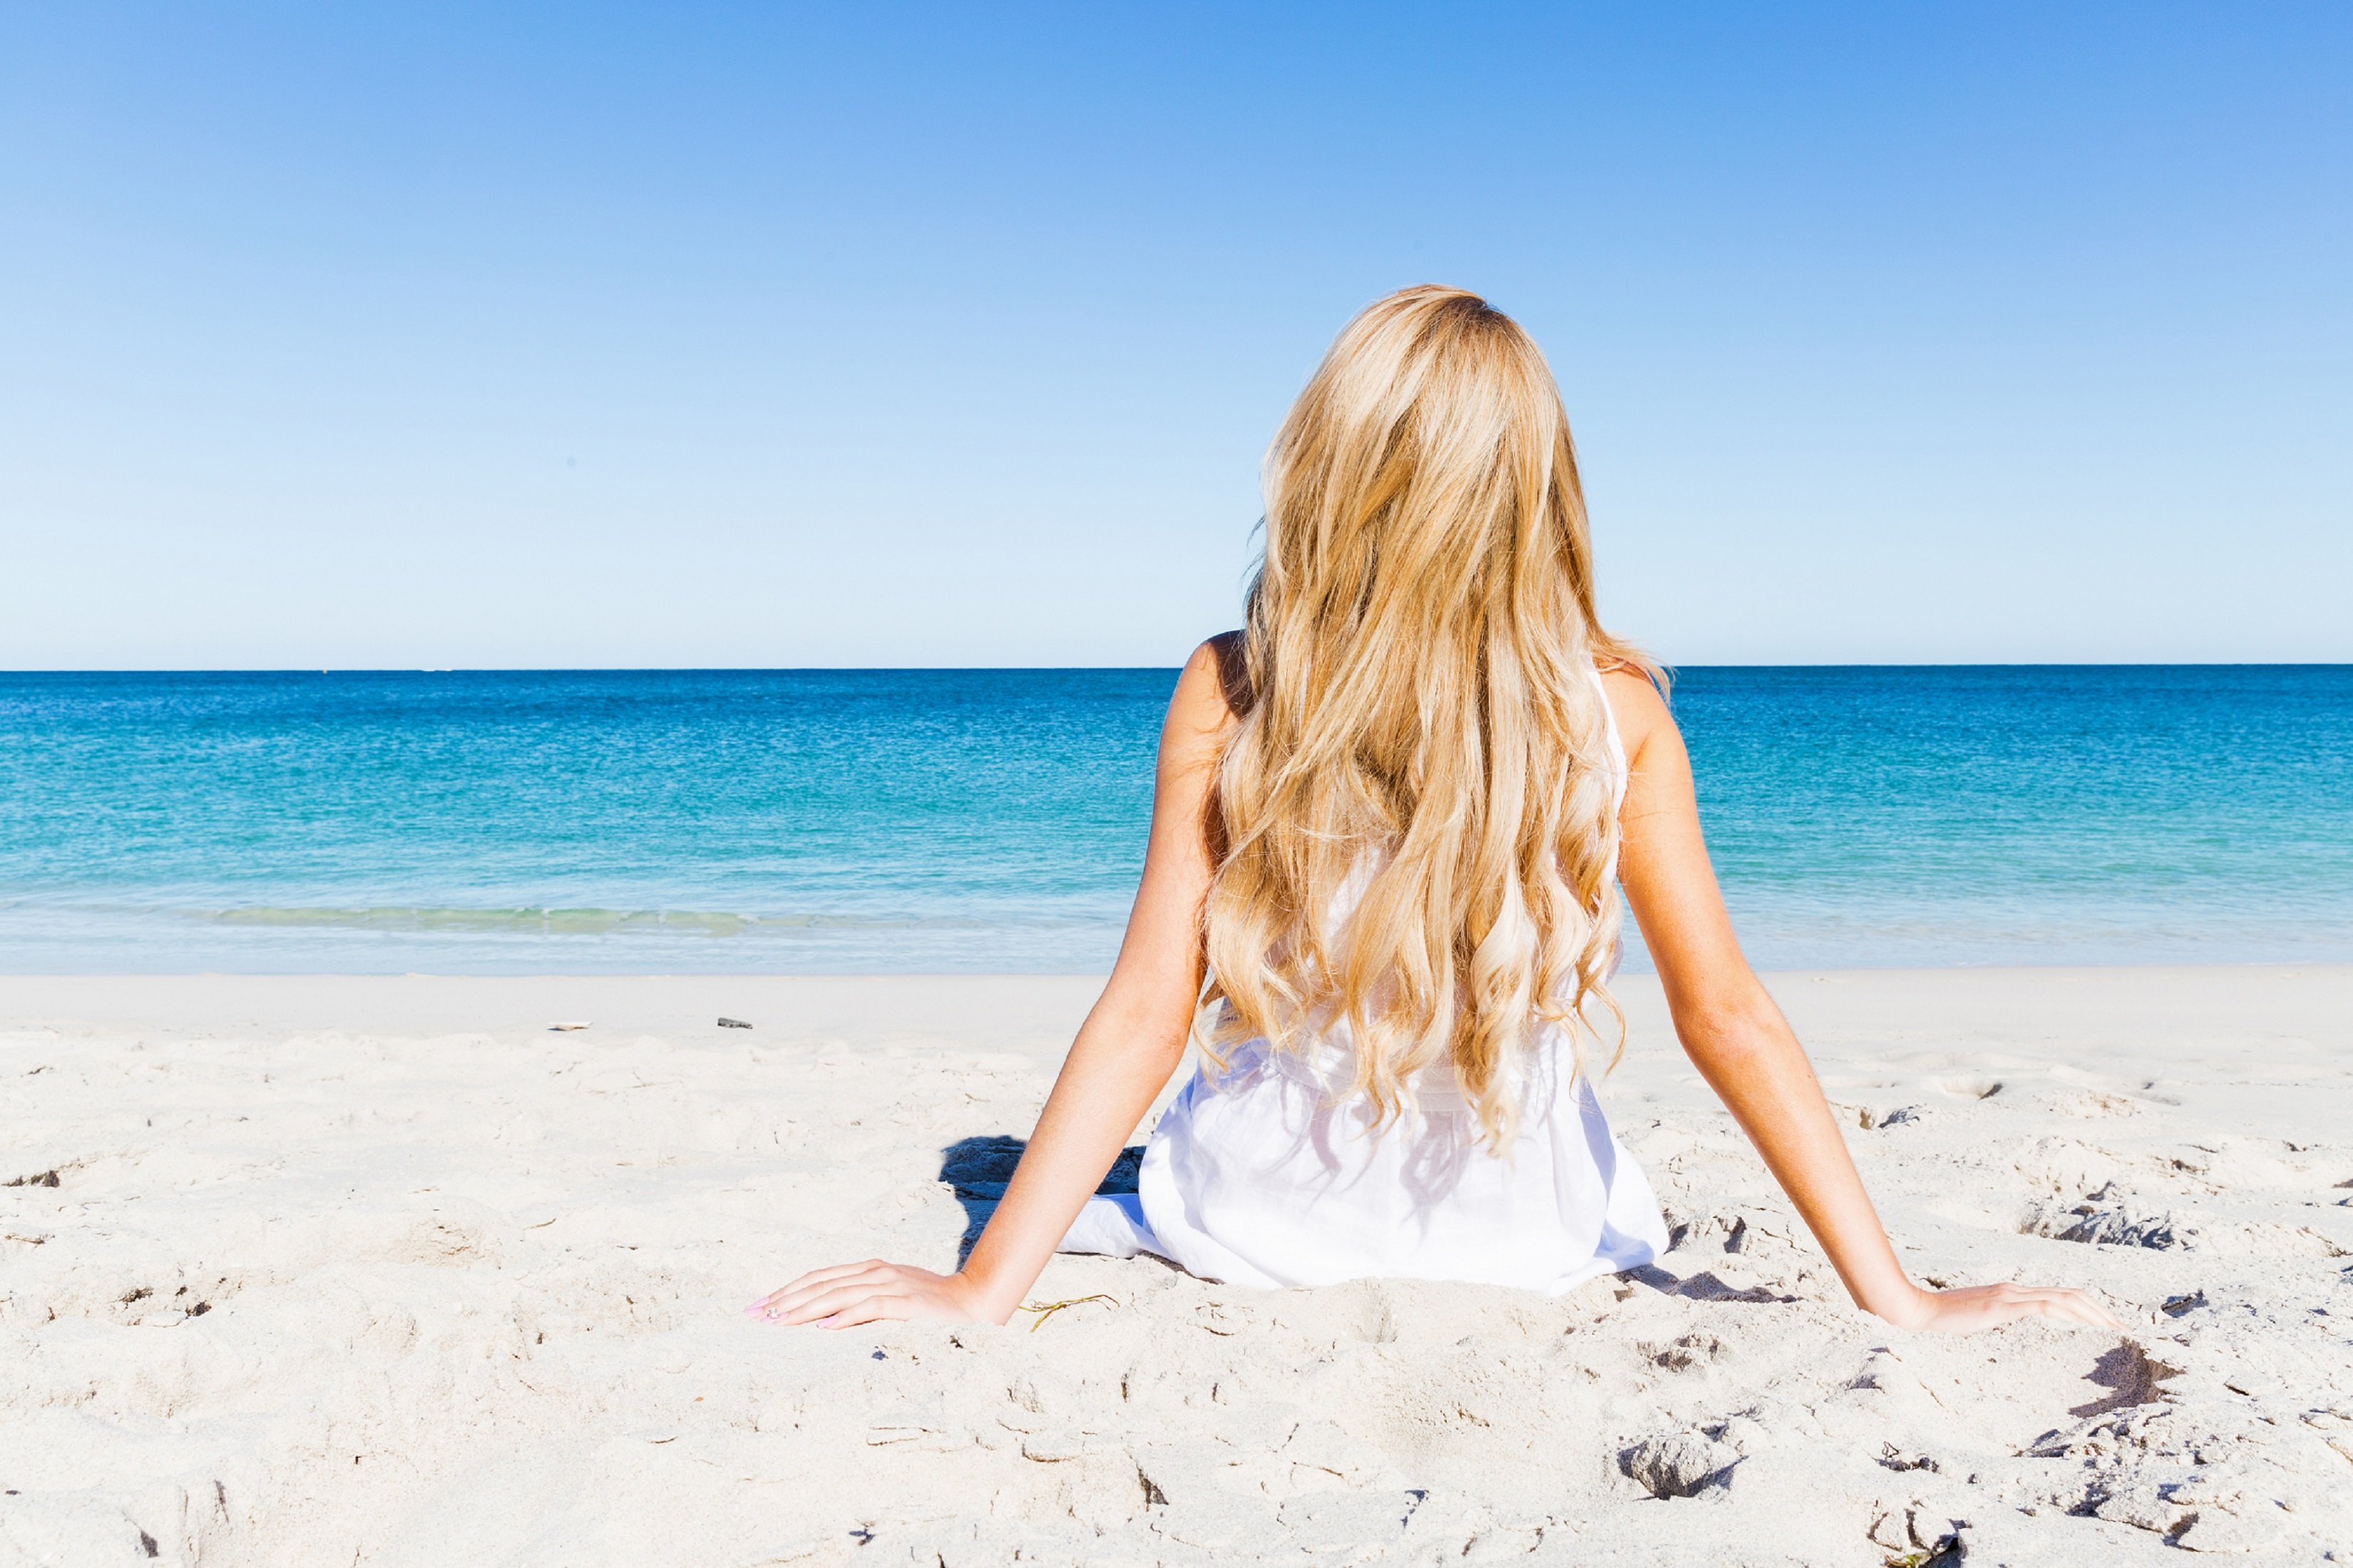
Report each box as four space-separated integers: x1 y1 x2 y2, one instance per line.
0 968 2353 1566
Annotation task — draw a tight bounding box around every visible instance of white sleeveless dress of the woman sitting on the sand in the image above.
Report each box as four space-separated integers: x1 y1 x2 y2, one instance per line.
1061 676 1666 1295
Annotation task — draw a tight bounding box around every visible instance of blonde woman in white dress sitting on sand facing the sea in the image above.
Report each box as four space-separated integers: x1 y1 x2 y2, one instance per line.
751 287 2116 1331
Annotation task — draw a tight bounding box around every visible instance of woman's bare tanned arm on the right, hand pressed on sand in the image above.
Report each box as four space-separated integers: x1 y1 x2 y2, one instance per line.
1602 673 2123 1333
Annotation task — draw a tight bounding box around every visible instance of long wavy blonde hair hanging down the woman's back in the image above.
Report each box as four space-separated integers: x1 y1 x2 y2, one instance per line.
1202 285 1661 1147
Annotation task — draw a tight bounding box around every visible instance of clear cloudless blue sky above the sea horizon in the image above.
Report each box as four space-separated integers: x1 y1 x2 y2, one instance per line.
0 2 2353 669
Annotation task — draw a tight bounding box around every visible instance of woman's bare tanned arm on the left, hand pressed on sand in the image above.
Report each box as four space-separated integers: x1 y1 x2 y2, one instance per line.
751 642 1233 1328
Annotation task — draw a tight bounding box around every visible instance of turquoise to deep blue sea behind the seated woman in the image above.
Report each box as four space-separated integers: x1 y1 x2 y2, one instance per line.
0 664 2353 973
